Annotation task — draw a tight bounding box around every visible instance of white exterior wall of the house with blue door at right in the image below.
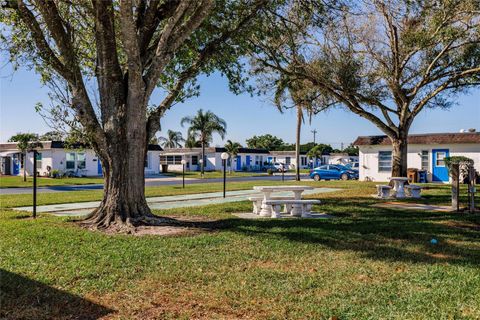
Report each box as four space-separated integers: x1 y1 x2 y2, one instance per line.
359 144 480 181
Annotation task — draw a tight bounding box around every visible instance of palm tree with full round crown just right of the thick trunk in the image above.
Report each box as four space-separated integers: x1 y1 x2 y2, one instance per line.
180 109 227 176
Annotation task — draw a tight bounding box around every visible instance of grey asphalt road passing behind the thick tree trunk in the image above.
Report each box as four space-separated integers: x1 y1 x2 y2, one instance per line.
0 175 308 194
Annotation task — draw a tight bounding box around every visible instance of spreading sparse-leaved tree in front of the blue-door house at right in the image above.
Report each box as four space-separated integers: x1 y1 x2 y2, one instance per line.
251 0 480 176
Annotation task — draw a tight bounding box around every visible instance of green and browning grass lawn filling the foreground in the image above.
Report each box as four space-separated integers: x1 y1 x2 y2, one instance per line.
0 181 480 319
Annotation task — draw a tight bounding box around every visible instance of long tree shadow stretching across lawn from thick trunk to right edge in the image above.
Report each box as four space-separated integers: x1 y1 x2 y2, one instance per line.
162 198 480 266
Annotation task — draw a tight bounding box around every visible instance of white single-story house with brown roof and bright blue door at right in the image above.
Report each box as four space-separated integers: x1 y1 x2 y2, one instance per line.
353 132 480 182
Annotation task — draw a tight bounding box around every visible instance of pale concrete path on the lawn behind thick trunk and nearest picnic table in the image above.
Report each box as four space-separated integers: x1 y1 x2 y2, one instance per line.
14 188 341 216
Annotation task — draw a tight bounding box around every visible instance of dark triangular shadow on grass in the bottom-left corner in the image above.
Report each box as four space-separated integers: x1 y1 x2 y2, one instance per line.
0 269 113 319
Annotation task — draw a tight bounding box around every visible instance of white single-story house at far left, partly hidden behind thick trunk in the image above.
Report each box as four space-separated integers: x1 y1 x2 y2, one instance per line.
0 141 162 177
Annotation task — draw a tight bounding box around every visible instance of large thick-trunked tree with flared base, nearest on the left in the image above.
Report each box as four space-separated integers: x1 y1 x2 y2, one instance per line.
0 0 267 230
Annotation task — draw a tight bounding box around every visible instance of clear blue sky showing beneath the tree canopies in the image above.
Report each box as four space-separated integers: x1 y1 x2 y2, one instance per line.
0 64 480 148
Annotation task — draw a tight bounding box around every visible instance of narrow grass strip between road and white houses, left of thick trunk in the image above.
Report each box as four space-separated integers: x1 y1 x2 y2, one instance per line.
0 176 103 188
